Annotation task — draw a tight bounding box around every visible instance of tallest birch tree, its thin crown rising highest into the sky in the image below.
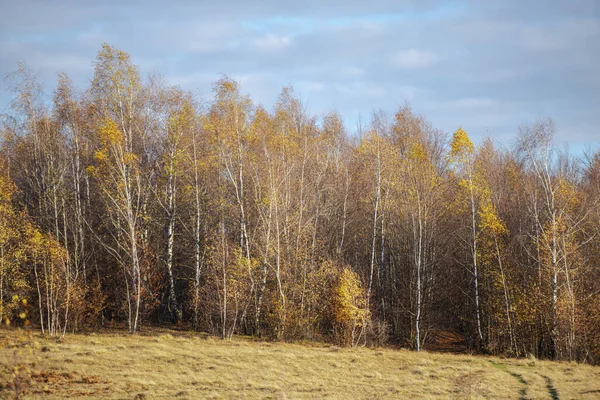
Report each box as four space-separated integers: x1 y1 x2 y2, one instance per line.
88 44 146 332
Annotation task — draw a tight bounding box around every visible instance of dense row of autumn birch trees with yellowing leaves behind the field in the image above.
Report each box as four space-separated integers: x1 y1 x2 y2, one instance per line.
0 44 600 363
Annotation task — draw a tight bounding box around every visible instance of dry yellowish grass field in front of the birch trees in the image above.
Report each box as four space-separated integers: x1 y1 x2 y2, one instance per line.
0 330 600 399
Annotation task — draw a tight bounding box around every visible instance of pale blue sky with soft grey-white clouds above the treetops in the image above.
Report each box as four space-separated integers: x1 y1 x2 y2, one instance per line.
0 0 600 148
